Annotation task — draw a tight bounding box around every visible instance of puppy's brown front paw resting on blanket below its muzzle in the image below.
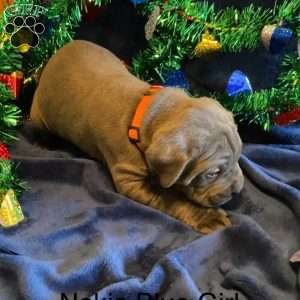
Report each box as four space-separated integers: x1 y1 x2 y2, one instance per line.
197 208 231 234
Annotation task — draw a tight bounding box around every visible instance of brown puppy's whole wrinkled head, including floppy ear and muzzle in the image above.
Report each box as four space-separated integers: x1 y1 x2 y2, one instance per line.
145 90 244 207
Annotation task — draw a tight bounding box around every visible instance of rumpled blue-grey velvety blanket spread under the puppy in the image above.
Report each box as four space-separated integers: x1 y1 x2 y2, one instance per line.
0 124 300 300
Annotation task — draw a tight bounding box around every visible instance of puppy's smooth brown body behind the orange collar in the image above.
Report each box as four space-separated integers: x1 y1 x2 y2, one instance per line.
30 40 148 162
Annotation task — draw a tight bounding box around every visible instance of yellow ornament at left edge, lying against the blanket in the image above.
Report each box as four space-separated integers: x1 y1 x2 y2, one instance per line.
0 189 24 227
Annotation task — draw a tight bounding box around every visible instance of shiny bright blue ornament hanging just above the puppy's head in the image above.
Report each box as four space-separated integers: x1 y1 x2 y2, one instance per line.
226 70 253 96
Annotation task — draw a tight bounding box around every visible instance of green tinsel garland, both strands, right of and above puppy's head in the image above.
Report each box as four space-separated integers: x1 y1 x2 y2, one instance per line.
132 0 300 130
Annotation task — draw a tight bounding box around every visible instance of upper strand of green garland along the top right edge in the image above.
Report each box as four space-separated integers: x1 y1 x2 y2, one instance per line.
141 0 300 52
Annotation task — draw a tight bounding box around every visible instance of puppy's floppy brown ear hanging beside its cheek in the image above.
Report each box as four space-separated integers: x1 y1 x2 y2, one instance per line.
145 138 189 188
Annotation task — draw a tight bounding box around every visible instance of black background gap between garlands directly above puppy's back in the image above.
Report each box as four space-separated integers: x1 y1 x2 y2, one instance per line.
75 0 147 62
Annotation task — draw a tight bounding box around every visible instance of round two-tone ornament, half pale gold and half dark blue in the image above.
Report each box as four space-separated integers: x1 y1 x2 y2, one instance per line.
261 25 293 54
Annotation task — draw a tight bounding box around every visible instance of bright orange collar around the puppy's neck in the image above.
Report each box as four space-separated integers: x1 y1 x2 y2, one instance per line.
128 85 162 144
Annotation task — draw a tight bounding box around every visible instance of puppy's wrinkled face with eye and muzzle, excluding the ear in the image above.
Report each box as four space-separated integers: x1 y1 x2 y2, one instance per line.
174 141 244 207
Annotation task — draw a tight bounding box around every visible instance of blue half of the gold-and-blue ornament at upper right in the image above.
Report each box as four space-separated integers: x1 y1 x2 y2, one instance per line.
270 27 293 54
